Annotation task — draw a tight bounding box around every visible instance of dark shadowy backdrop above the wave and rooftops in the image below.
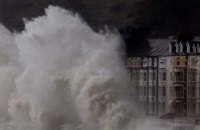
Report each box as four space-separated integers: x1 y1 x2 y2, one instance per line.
0 0 200 34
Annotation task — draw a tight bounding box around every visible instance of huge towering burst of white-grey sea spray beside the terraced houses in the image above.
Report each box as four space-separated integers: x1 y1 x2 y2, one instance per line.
0 6 140 130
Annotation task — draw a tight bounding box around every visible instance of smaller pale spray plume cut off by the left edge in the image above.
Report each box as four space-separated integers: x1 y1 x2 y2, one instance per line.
0 25 20 119
